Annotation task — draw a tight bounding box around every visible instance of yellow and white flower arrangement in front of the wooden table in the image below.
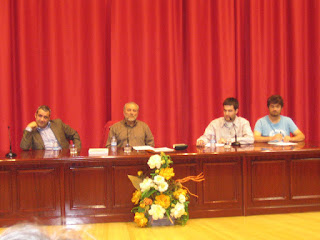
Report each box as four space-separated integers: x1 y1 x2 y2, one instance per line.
128 153 204 227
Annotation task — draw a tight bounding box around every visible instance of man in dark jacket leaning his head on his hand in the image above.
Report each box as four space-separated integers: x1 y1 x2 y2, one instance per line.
20 105 81 150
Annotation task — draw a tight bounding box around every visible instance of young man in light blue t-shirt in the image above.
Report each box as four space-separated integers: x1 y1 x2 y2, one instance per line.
254 95 305 142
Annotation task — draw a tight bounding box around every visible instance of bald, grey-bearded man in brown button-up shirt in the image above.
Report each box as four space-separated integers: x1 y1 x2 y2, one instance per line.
106 102 154 147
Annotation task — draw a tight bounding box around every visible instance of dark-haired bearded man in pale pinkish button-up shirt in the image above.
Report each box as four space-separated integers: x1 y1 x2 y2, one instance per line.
197 98 254 146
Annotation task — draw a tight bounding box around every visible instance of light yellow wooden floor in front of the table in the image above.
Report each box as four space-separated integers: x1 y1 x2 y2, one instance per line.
0 212 320 240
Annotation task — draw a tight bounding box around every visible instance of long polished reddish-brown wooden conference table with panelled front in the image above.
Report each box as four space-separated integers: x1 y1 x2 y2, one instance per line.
0 143 320 226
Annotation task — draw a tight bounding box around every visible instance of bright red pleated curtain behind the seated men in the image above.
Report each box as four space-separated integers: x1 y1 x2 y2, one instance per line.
0 0 320 152
